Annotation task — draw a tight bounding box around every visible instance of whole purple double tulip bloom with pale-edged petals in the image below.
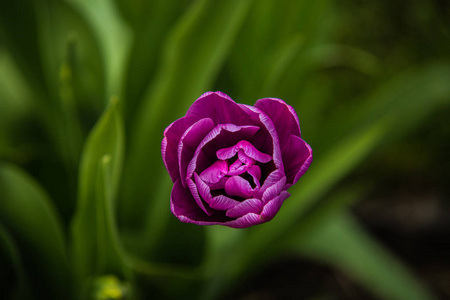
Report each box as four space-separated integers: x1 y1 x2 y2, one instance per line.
161 92 312 228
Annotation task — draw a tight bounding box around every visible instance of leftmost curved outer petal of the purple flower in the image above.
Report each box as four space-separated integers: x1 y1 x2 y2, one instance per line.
161 117 196 182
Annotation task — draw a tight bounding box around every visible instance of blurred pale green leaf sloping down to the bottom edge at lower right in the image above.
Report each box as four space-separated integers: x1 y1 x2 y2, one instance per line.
289 212 435 300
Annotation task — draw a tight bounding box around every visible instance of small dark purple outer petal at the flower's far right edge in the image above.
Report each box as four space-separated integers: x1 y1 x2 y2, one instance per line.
283 135 312 187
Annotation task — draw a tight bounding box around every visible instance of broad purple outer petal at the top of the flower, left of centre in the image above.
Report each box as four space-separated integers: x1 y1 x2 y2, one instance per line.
186 92 256 125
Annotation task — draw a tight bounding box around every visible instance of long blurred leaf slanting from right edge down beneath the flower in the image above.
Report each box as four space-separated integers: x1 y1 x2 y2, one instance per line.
205 64 450 296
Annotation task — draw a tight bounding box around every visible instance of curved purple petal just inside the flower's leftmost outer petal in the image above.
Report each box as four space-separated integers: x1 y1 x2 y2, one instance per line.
178 118 214 187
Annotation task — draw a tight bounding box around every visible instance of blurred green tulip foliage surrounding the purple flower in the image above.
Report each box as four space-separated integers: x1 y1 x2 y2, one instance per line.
0 0 450 300
